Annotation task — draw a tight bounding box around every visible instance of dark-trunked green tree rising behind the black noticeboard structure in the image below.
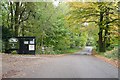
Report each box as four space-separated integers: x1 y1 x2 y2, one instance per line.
2 1 34 37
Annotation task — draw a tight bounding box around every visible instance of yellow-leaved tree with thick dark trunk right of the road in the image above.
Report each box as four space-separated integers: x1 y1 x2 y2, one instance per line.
68 2 119 52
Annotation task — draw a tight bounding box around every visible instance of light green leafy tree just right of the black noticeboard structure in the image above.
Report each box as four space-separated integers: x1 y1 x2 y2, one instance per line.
24 2 69 53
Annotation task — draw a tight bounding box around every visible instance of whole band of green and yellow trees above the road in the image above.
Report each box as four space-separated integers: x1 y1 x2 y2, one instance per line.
0 1 119 54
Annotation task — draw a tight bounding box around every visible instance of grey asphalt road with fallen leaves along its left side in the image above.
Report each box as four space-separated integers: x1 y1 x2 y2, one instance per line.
3 46 118 78
